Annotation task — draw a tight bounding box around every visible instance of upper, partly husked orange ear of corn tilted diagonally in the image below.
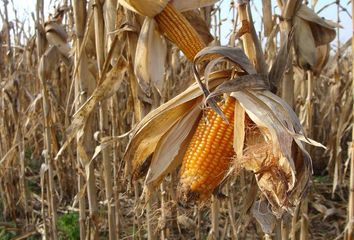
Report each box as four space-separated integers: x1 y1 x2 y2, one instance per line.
155 3 206 60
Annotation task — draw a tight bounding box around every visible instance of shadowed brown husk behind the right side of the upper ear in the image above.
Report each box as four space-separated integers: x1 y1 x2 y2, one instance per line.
183 10 214 45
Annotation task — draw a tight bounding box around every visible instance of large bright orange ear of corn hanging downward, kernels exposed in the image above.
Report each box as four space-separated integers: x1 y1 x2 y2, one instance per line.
179 97 235 202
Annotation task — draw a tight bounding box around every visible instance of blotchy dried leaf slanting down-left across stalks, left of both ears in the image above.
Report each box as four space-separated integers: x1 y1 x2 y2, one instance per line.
55 58 127 159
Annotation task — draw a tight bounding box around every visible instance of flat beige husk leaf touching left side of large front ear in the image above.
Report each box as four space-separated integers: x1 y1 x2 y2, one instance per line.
145 106 201 189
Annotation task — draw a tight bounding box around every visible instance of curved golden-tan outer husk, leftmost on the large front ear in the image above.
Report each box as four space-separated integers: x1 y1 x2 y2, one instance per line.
124 71 230 177
